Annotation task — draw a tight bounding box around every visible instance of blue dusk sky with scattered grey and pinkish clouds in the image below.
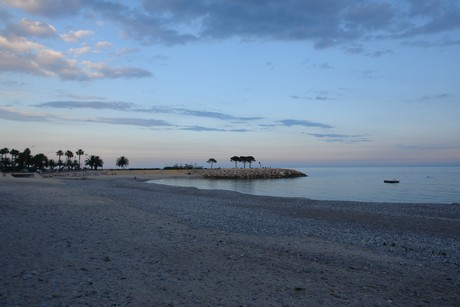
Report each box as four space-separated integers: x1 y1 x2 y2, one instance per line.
0 0 460 168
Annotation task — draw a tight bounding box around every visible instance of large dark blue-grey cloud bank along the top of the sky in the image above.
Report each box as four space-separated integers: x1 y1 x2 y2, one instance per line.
1 0 460 48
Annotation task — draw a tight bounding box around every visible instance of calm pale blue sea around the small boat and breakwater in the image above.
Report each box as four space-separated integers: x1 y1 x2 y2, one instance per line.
149 167 460 203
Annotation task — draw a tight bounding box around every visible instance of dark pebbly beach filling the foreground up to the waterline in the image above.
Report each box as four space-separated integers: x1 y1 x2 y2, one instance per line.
0 176 460 306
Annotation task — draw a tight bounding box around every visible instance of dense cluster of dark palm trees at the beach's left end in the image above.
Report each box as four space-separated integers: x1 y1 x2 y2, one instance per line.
0 147 104 172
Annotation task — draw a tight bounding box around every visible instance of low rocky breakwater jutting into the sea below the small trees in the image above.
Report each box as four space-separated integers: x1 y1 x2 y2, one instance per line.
199 168 307 179
